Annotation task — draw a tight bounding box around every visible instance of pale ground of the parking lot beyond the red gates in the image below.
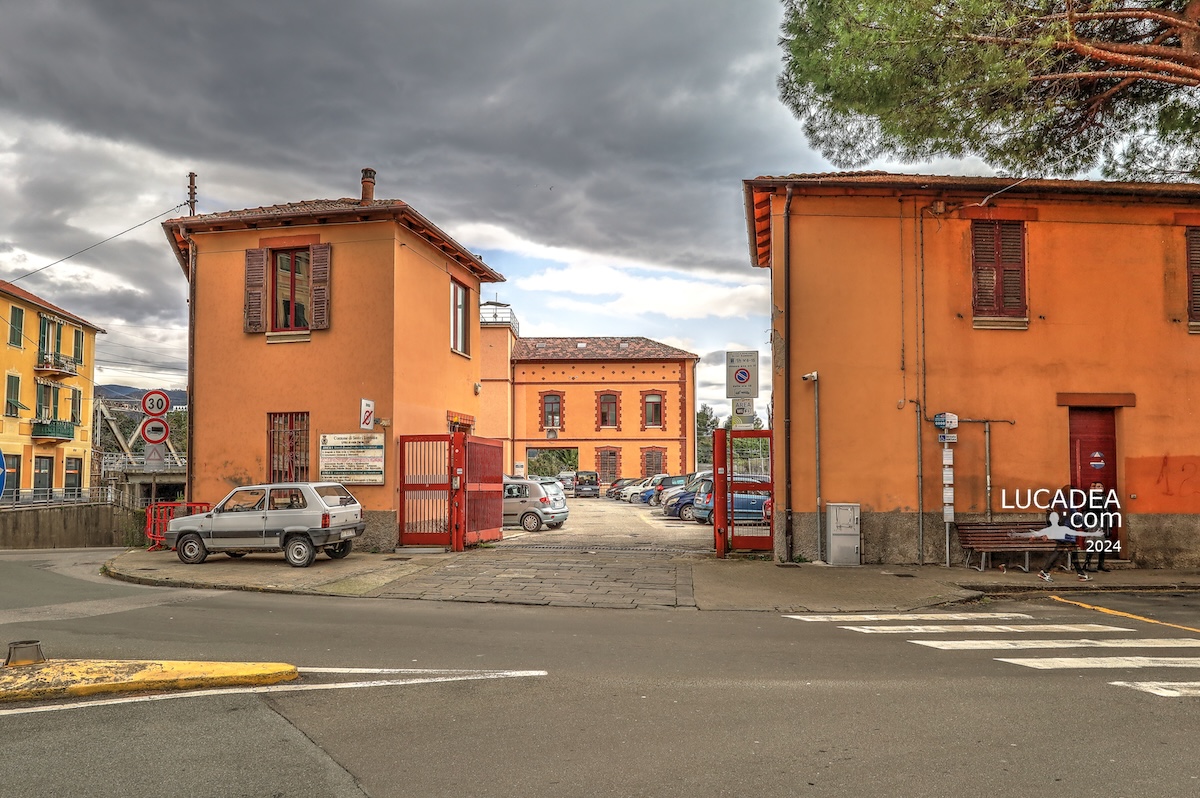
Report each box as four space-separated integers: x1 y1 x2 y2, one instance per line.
497 489 713 552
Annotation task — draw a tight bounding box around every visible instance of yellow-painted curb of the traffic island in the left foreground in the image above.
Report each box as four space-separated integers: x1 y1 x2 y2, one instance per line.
0 660 300 702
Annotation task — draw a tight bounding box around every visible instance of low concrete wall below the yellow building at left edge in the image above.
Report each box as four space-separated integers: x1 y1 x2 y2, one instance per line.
0 504 145 548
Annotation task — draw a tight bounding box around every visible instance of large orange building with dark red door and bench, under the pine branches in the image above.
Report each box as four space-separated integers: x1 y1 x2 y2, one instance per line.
744 173 1200 566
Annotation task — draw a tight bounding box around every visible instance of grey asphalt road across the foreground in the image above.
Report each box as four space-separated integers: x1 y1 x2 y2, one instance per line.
0 552 1200 798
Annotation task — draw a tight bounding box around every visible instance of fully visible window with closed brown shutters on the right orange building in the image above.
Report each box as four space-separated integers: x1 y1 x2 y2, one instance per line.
971 220 1028 326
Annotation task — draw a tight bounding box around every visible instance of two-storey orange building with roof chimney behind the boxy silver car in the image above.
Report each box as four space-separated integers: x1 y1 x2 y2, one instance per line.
163 169 503 547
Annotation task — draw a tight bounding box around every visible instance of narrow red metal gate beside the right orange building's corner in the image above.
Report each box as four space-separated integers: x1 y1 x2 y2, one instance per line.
713 430 775 557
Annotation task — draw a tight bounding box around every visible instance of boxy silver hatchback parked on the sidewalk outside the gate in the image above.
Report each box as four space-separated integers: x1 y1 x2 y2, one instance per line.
163 482 367 568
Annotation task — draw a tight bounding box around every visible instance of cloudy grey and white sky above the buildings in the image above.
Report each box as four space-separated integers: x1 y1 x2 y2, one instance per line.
0 0 974 415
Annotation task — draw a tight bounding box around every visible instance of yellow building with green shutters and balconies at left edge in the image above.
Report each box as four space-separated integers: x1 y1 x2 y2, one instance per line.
0 281 103 503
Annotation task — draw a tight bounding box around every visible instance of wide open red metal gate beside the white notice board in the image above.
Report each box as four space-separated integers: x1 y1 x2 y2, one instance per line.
396 432 504 551
